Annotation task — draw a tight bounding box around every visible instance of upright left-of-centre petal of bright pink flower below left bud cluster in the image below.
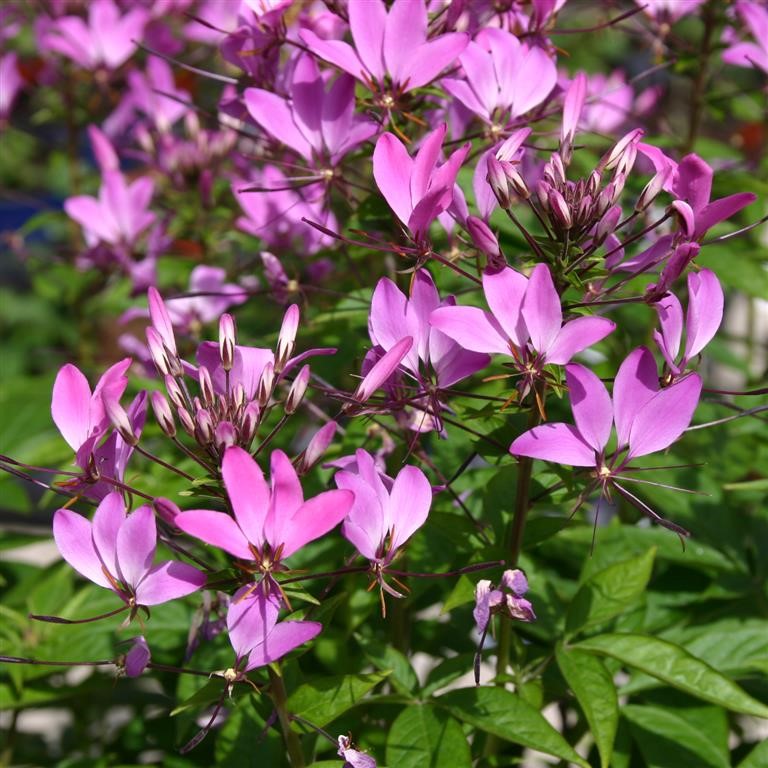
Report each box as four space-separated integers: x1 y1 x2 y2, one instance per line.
222 446 271 544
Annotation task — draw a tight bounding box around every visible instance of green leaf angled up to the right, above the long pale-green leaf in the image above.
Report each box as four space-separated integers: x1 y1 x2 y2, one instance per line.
565 547 656 635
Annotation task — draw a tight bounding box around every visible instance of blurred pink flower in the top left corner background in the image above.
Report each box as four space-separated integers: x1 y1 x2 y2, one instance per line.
38 0 149 70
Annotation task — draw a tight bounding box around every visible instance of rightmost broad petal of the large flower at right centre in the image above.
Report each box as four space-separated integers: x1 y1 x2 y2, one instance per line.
627 373 702 459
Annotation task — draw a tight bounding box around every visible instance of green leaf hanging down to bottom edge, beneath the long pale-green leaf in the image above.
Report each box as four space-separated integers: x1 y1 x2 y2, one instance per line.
555 646 619 768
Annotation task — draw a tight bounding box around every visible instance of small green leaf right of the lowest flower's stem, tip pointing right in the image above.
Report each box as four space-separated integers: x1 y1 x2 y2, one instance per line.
288 672 389 728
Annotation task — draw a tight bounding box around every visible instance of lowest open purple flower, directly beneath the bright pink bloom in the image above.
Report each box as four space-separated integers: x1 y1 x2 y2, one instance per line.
227 584 323 672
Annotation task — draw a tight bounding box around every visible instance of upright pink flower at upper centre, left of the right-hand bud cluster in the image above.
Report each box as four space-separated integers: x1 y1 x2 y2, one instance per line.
370 124 470 242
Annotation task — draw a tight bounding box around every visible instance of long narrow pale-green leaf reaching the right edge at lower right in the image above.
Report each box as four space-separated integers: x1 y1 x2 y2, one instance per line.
574 633 768 717
